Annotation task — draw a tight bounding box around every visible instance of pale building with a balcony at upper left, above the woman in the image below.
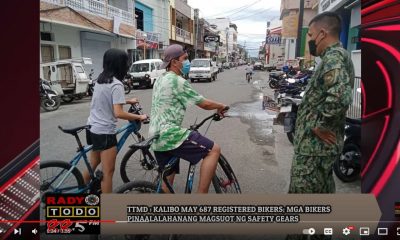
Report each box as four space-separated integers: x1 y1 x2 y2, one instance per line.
40 0 136 77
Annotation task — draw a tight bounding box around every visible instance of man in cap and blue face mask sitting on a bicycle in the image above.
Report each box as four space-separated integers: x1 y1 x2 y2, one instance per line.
149 44 226 193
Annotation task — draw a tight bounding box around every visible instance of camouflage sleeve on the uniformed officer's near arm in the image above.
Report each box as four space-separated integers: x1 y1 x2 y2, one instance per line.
317 58 353 127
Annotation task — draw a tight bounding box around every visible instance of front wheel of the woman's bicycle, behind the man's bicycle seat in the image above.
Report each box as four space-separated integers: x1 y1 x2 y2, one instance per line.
120 148 157 183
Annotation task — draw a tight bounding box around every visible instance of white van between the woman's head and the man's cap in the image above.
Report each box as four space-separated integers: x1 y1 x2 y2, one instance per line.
128 59 165 88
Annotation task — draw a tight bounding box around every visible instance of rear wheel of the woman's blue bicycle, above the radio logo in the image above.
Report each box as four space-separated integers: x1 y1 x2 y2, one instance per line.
40 161 85 232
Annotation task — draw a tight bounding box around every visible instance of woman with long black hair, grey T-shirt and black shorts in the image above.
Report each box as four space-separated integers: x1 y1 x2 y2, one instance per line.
83 49 147 193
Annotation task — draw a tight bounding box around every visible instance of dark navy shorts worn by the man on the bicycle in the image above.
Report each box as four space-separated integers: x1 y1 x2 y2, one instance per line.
154 131 214 173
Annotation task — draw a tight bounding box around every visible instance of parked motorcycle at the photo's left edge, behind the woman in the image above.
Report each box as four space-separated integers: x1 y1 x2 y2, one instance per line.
39 79 61 112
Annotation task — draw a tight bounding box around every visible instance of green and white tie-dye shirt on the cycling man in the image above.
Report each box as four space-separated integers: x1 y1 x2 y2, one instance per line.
149 72 204 151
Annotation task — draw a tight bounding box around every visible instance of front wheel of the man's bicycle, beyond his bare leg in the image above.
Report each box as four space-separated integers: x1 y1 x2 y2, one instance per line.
212 154 242 193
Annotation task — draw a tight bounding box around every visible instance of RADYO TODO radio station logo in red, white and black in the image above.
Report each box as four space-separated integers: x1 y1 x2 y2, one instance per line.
45 193 100 234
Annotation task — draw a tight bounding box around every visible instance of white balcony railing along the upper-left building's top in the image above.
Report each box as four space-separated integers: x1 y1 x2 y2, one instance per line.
41 0 134 26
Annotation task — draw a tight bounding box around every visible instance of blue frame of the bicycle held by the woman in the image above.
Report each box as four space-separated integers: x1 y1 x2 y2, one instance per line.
51 122 142 193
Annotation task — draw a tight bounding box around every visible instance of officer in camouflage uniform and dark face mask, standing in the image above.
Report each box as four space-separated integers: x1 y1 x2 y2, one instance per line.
287 12 354 239
